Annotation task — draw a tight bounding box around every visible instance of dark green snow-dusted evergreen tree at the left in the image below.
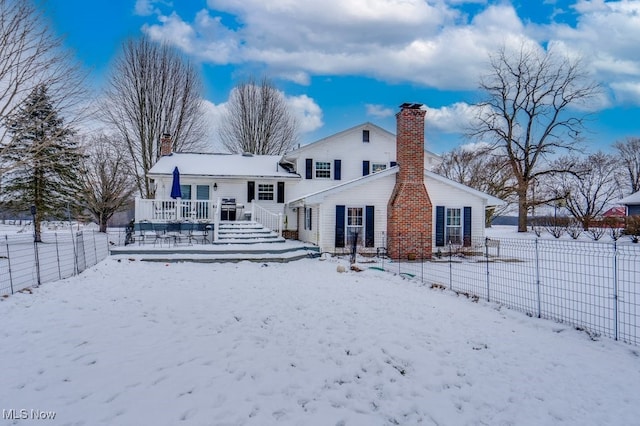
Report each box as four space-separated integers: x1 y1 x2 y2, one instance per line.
2 85 82 242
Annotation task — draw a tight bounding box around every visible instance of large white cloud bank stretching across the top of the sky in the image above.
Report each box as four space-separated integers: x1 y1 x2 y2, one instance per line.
137 0 640 106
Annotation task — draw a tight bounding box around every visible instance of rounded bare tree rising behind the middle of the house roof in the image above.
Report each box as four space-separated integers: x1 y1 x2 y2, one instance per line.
219 79 298 155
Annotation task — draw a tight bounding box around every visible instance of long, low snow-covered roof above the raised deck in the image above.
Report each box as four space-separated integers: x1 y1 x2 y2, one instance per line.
148 152 300 179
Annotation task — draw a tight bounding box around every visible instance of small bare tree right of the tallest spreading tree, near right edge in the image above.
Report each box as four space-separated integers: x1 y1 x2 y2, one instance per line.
557 152 618 230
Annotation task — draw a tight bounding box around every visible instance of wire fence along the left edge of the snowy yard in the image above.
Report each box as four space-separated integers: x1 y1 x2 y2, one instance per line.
0 230 109 295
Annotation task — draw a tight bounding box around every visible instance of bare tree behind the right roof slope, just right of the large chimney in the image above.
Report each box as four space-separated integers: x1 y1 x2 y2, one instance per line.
434 147 515 227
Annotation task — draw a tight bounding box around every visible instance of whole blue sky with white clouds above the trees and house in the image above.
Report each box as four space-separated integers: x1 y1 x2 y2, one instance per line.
44 0 640 153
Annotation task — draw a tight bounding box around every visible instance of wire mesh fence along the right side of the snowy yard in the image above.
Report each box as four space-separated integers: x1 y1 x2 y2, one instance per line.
350 236 640 345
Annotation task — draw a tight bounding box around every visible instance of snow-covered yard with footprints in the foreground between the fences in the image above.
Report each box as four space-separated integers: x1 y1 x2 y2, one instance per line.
0 257 640 425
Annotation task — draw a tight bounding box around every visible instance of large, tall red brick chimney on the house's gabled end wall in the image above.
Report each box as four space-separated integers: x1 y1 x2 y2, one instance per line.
387 103 433 260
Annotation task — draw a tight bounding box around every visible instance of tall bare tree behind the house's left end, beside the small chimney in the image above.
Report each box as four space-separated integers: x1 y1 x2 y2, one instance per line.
101 37 205 198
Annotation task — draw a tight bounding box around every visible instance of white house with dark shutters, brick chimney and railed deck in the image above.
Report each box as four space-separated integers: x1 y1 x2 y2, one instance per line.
136 104 503 257
